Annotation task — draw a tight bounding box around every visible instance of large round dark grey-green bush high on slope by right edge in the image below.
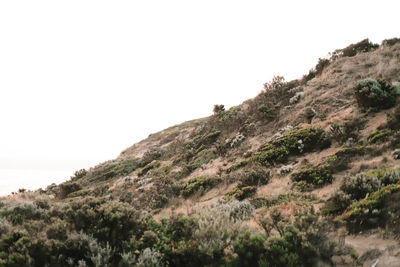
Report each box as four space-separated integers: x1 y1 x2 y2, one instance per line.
354 78 396 110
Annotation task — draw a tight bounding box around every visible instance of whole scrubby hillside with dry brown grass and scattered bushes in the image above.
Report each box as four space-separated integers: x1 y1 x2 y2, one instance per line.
0 38 400 266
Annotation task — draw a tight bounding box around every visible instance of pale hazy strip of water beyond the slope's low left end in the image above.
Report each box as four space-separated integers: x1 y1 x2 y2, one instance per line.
0 169 73 196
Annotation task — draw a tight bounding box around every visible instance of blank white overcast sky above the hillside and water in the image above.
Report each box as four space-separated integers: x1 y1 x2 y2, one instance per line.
0 0 400 170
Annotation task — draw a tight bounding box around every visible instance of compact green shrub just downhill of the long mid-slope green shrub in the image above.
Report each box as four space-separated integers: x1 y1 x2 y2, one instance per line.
291 166 333 191
